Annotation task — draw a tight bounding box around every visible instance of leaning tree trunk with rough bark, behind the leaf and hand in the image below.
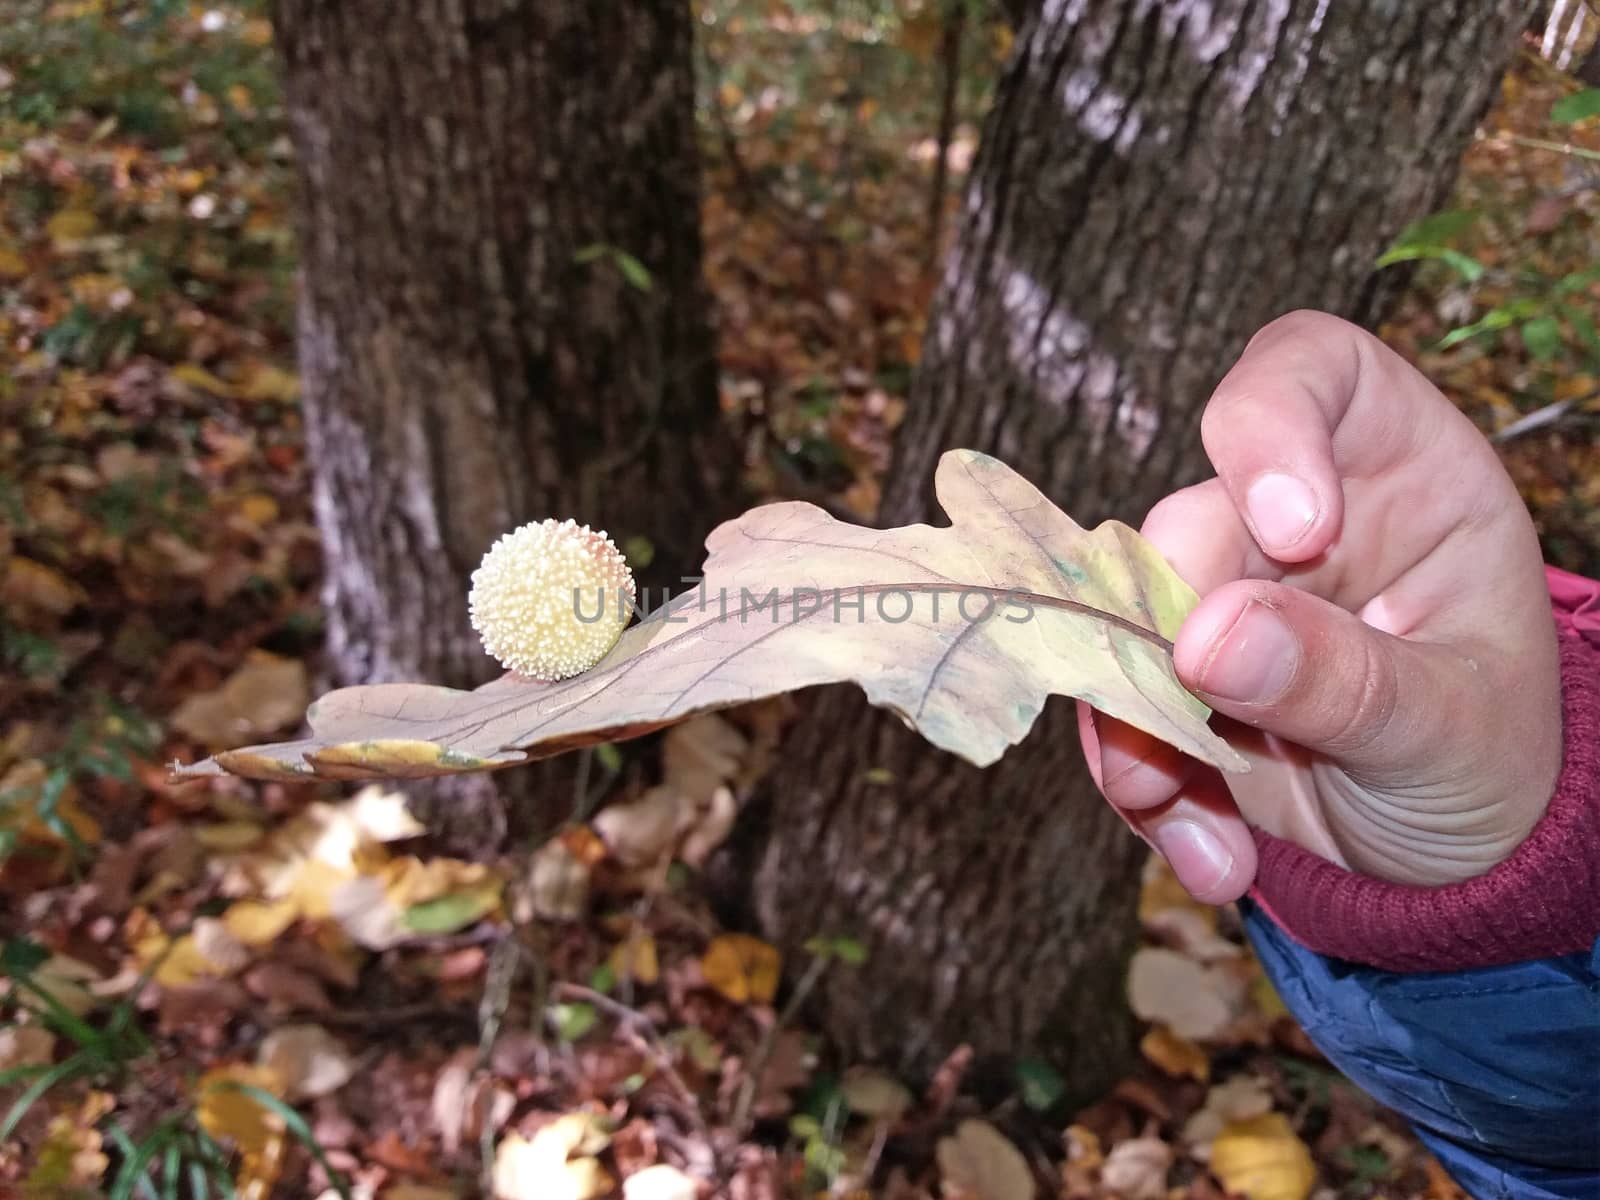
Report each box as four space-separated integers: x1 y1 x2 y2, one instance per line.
755 0 1525 1094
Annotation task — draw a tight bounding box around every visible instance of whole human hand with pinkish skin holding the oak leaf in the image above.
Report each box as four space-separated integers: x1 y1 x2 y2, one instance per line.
1078 312 1562 904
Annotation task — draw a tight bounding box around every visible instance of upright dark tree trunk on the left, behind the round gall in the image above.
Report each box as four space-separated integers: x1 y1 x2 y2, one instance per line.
272 0 736 838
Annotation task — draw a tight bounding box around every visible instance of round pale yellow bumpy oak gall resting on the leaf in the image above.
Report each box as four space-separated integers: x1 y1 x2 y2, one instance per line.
467 520 635 682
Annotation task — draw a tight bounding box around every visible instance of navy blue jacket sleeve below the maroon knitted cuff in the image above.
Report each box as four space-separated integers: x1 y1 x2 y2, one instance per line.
1240 901 1600 1200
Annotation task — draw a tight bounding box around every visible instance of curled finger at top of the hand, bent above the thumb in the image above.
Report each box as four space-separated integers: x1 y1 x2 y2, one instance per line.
1200 312 1368 563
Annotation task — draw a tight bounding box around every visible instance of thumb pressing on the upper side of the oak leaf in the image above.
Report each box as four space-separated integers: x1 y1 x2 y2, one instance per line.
1173 579 1474 784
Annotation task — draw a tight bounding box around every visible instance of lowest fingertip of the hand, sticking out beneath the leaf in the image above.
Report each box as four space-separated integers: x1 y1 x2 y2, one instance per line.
1131 768 1258 904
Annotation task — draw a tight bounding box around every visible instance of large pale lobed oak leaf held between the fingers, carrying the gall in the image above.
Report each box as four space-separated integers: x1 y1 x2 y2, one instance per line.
178 451 1248 779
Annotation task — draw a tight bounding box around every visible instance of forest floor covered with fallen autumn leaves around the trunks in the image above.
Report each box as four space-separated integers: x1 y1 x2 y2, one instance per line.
0 5 1600 1200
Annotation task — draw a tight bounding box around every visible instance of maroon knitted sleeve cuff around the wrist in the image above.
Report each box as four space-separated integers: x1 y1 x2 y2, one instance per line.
1251 568 1600 971
